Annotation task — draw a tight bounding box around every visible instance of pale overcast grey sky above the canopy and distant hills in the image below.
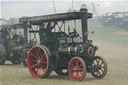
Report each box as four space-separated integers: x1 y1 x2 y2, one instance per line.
0 0 128 19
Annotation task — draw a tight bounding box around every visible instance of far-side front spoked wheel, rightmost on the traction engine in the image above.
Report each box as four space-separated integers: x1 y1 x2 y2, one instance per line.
92 56 107 79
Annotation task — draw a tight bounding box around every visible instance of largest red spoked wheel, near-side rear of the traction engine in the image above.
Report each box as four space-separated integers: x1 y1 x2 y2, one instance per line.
27 46 51 78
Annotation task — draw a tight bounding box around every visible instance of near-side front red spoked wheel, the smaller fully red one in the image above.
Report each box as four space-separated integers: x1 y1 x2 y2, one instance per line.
68 57 86 81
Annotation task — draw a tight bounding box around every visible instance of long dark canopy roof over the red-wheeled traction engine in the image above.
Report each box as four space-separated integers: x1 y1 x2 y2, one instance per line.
19 12 92 23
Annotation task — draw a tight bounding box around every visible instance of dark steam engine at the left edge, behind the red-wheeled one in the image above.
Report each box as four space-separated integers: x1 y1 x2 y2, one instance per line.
0 24 31 65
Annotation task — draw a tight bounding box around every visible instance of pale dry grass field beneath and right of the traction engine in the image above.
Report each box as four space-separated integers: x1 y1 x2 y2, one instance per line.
0 23 128 85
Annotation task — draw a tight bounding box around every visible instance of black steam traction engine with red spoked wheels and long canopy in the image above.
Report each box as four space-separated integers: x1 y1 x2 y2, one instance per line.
20 6 107 81
